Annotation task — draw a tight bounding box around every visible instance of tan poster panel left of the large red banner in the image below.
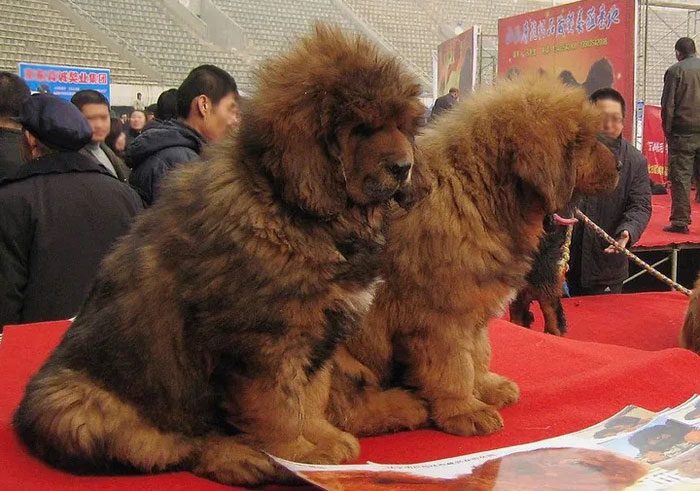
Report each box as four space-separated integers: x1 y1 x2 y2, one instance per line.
437 26 479 97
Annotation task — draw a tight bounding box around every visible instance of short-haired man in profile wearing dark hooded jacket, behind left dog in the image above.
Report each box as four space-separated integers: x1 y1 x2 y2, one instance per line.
126 65 239 206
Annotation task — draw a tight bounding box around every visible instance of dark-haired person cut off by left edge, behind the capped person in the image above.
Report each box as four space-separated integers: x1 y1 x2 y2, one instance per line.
0 72 30 179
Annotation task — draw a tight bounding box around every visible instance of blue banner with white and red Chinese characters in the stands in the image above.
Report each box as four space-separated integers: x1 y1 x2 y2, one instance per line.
18 63 110 100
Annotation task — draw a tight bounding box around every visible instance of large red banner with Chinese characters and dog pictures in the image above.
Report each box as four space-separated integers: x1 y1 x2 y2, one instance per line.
498 0 636 141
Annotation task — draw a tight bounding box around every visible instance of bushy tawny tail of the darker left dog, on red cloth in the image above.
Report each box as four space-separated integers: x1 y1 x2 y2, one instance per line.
13 367 197 474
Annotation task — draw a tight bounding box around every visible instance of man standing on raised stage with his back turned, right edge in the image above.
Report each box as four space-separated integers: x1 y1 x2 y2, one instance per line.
661 38 700 234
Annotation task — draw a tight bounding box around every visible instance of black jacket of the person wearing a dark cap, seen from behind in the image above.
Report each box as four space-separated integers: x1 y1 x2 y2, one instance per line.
0 152 143 326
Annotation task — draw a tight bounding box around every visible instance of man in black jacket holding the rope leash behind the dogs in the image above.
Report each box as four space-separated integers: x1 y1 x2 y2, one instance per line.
567 88 651 295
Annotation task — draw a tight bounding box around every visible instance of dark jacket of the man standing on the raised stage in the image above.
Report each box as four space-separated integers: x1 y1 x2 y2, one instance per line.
661 55 700 138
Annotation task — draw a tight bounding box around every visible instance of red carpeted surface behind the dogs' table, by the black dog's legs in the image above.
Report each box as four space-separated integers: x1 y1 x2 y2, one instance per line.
531 292 688 351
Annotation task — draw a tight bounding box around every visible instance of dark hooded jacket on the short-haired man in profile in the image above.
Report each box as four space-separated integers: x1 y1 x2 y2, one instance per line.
126 119 204 205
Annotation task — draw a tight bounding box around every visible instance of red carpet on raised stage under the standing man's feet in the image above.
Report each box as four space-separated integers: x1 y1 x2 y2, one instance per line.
634 194 700 248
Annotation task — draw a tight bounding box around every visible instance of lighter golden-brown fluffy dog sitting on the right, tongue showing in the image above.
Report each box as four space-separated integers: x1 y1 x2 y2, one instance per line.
329 78 617 435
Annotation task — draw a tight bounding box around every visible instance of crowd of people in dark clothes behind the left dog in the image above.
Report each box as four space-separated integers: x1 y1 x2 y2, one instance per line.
0 65 240 326
